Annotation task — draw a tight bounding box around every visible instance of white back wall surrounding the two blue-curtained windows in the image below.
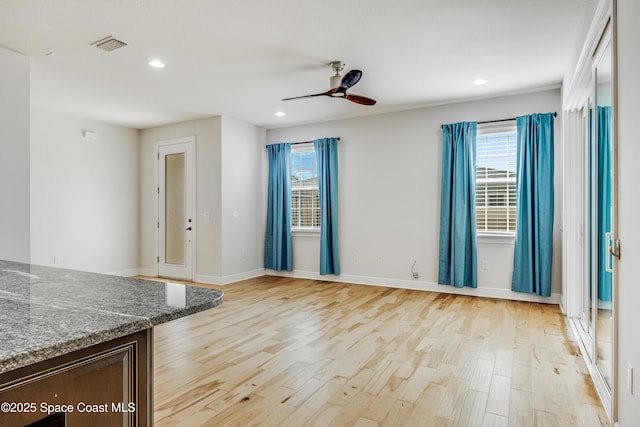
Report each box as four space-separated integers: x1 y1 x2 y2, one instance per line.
263 90 562 303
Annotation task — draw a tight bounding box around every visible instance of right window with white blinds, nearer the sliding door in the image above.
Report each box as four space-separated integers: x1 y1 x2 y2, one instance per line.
476 126 517 234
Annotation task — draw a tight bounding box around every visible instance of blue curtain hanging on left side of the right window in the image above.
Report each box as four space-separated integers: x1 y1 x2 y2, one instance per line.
438 122 478 288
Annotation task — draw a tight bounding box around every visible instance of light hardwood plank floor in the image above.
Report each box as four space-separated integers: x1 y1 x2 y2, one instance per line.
149 276 609 427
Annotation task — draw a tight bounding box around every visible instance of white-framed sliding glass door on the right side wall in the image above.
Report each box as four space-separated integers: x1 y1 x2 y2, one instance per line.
562 0 620 420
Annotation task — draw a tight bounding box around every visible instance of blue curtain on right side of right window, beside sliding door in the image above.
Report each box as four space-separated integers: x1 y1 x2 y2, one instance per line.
511 113 554 297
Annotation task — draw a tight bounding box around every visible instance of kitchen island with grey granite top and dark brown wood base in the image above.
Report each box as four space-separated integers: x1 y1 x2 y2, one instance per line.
0 261 223 427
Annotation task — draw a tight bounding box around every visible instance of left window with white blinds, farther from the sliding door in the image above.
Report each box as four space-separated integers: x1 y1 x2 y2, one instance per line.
291 145 320 230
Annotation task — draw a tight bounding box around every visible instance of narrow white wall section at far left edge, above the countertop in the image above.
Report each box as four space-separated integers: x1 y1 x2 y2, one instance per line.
0 47 30 262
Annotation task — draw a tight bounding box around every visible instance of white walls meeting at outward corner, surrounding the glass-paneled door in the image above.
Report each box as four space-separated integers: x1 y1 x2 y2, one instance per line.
140 117 264 284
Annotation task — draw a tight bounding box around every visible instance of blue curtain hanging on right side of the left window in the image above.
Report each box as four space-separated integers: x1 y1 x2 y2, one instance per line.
313 138 340 274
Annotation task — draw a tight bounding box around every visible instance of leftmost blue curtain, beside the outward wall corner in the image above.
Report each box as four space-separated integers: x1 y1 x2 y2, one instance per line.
264 144 293 271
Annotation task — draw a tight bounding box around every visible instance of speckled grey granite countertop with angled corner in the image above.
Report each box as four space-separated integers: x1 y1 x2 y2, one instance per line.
0 260 223 374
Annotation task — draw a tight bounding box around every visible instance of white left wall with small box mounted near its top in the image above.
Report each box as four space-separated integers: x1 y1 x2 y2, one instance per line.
31 109 138 274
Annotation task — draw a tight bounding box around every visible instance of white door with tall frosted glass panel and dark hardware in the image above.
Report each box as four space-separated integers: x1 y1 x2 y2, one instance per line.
156 138 195 280
